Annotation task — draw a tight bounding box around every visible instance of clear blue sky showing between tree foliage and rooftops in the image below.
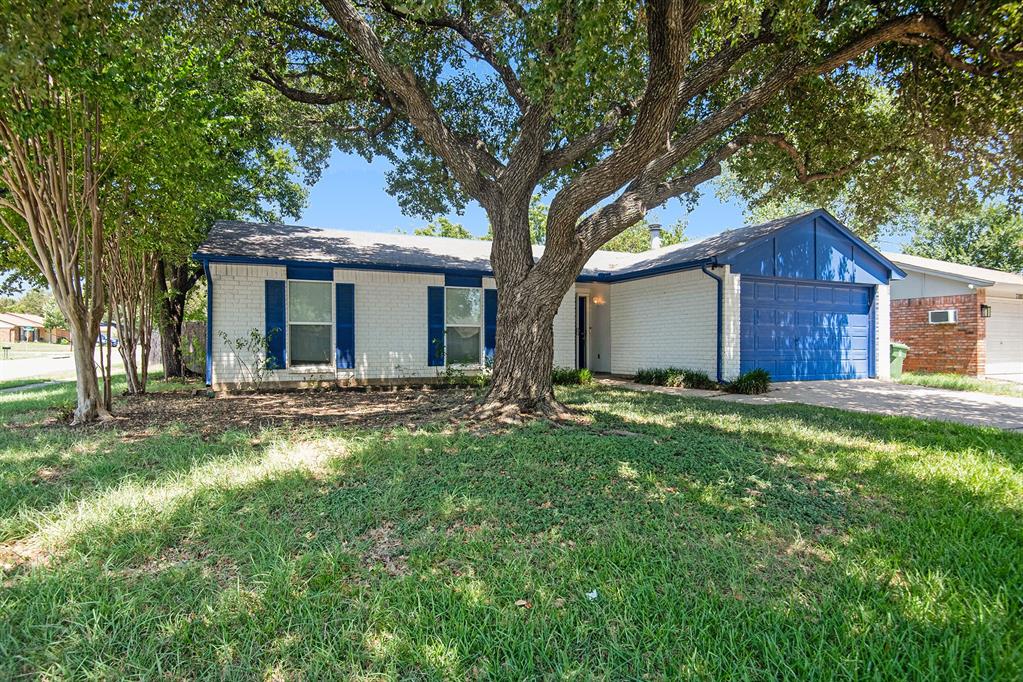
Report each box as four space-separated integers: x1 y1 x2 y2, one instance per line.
298 150 912 249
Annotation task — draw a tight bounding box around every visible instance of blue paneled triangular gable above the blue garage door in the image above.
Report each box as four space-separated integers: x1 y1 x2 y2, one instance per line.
722 216 890 284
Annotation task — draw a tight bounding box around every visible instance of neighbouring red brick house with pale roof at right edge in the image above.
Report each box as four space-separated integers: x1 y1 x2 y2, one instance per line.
886 254 1023 378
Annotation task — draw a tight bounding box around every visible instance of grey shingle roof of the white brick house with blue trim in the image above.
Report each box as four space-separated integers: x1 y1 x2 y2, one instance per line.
194 210 902 281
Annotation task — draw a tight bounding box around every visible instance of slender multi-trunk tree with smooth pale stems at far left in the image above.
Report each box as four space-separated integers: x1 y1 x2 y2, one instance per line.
0 0 304 422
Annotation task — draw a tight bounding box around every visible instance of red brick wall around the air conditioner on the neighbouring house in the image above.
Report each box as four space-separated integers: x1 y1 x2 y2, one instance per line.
891 290 985 376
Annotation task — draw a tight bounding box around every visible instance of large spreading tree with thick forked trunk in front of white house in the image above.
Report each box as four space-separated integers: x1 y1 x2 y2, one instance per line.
247 0 1023 418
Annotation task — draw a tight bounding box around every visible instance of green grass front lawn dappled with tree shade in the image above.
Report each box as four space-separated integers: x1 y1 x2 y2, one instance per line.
0 387 1023 680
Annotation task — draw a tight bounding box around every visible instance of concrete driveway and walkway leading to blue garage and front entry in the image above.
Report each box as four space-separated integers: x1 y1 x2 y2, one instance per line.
598 377 1023 431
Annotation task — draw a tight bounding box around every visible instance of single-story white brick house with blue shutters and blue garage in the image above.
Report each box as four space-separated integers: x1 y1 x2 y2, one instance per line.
194 211 903 389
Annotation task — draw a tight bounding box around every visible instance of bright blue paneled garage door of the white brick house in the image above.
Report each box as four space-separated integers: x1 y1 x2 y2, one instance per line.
740 275 874 381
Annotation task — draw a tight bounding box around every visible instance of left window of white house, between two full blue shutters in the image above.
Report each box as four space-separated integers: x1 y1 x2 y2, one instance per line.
287 280 332 366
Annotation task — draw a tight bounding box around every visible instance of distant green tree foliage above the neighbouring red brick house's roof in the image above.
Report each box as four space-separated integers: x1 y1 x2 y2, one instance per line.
905 203 1023 273
